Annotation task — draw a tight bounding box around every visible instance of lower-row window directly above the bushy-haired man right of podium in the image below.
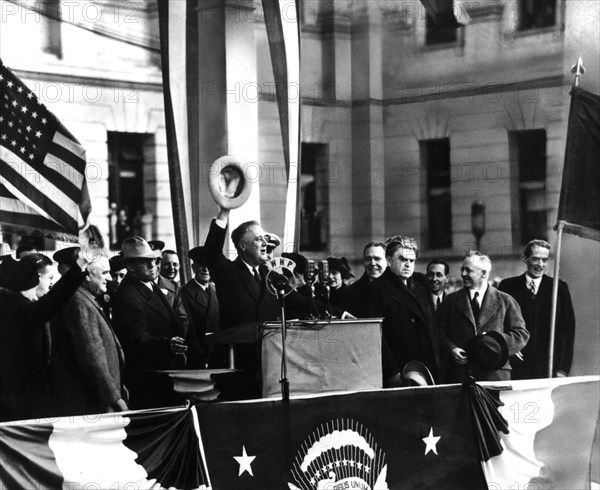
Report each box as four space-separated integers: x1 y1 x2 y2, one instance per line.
419 138 452 248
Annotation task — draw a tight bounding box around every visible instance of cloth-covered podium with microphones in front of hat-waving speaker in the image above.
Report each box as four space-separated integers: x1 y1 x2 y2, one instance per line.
261 318 383 398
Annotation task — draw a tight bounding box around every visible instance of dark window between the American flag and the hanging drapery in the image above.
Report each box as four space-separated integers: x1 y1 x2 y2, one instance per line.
108 132 150 248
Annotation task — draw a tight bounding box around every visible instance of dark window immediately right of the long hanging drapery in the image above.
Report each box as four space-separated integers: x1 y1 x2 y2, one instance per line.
300 143 329 251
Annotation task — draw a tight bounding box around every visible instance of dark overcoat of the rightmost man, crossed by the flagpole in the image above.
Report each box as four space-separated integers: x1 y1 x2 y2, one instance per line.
498 274 575 379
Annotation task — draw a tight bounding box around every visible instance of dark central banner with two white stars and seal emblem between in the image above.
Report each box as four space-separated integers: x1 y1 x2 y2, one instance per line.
196 386 487 490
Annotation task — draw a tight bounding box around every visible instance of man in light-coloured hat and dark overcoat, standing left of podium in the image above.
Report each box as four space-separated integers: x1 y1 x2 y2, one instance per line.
113 237 188 408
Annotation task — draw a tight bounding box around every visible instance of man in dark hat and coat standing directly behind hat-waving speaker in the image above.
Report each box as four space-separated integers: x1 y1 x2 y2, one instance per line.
181 247 219 367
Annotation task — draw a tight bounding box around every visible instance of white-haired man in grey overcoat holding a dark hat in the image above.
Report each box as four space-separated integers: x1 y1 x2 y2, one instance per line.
437 252 529 383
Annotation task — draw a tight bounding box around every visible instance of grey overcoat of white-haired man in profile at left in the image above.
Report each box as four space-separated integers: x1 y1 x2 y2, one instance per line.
50 285 127 415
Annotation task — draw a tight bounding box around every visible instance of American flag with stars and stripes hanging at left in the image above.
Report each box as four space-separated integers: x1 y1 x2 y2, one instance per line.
0 60 91 236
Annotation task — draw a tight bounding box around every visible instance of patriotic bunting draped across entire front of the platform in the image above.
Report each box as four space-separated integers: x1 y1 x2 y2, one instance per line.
0 376 600 490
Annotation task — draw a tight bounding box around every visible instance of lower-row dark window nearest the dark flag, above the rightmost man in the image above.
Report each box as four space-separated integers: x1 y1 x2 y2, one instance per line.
509 129 548 245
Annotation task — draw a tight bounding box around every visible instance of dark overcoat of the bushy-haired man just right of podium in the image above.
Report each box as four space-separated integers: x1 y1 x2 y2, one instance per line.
369 268 440 381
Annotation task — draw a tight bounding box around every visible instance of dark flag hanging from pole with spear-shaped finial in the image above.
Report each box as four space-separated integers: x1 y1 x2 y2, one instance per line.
558 87 600 241
